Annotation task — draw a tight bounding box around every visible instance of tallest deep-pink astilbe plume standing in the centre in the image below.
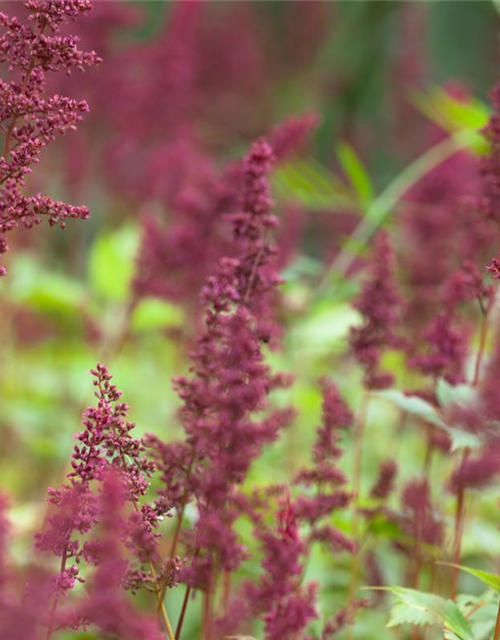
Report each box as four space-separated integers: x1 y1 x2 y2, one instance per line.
144 140 292 636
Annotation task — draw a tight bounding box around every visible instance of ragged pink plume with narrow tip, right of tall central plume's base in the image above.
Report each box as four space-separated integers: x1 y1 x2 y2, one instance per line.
218 379 356 640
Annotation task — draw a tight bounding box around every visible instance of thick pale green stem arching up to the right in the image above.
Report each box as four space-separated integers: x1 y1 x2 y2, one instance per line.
316 130 478 294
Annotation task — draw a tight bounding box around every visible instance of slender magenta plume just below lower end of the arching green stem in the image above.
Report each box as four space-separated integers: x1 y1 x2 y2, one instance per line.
350 232 402 389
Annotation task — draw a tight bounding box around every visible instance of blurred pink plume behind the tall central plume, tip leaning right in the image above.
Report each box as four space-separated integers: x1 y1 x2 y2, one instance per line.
133 114 318 314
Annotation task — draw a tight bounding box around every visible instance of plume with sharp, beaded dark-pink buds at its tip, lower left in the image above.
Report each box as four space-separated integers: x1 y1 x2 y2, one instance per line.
35 365 165 627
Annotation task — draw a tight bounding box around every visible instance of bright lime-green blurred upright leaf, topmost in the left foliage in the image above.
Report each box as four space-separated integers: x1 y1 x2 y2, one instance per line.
89 225 139 302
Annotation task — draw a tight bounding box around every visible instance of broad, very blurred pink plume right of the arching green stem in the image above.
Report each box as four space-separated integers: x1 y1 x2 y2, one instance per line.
401 136 482 329
